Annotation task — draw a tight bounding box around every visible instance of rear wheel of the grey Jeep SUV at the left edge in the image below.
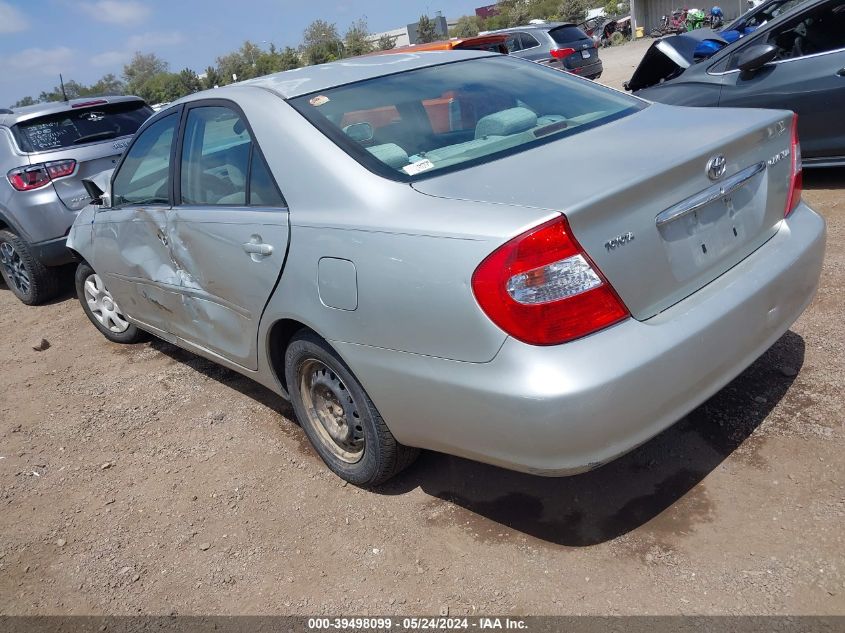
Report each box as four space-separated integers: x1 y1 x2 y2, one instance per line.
0 230 60 306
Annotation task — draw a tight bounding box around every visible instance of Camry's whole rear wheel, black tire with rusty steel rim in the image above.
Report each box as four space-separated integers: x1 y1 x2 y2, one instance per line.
285 331 419 486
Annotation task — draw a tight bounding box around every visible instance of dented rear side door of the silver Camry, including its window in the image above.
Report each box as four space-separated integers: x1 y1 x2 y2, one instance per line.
168 102 289 370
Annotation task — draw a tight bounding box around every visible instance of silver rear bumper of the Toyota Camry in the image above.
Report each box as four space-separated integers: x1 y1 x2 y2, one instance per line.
334 203 825 476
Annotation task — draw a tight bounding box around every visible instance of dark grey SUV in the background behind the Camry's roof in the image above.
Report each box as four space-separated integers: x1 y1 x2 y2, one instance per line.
489 22 604 79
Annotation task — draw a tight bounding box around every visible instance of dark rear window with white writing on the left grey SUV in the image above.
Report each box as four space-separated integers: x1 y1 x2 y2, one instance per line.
15 101 153 152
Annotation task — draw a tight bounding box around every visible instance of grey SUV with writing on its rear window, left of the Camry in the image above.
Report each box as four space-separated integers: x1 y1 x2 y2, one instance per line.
0 97 153 305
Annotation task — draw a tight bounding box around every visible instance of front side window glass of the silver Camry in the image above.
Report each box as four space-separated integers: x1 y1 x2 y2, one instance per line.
112 113 179 207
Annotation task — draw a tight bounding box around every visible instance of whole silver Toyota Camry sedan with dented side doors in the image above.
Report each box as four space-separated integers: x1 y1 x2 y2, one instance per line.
68 52 825 485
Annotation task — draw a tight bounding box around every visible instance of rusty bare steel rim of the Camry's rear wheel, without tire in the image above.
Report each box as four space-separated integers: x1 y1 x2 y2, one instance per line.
299 358 365 464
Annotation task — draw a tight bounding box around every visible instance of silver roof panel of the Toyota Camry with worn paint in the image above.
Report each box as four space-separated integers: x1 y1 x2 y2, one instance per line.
202 50 501 103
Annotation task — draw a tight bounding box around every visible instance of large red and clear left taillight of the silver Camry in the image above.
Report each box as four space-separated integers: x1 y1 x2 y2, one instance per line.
472 216 629 345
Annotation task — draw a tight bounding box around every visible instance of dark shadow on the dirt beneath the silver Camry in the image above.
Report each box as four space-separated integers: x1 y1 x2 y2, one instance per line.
151 324 804 547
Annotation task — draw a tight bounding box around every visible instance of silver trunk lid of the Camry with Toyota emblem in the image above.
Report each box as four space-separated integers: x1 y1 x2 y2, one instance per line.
412 104 792 320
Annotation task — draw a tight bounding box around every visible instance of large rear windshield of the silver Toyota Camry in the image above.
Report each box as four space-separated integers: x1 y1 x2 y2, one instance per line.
291 55 645 181
